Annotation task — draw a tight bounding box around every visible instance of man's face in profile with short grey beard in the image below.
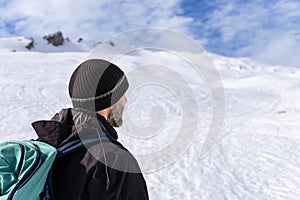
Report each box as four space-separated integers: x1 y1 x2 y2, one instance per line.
107 96 127 127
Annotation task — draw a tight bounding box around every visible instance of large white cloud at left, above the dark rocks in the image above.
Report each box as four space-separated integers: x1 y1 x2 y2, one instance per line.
0 0 192 40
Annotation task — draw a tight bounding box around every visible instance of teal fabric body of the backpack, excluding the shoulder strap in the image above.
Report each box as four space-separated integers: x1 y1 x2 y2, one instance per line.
0 140 57 200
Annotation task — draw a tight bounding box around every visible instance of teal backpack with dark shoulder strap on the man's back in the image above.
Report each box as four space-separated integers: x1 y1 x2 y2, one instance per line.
0 133 115 200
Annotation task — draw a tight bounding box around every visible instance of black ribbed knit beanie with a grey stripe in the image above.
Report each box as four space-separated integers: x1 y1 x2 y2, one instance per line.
69 59 129 111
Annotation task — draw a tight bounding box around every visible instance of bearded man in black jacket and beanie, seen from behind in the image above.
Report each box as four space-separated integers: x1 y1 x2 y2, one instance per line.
32 59 149 200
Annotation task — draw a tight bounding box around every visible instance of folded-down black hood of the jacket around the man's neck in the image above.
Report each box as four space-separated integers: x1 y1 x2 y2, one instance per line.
31 108 118 148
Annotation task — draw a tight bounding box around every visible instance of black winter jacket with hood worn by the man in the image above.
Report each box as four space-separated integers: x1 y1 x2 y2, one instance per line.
32 108 149 200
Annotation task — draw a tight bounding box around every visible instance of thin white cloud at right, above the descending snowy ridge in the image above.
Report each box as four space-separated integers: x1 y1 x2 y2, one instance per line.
204 0 300 66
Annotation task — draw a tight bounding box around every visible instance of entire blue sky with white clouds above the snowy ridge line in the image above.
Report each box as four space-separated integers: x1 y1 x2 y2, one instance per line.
0 0 300 66
